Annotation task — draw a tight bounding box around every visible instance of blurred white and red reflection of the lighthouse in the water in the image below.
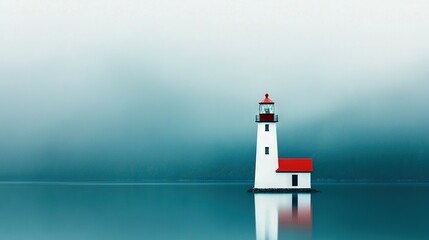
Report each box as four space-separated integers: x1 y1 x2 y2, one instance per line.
255 193 312 240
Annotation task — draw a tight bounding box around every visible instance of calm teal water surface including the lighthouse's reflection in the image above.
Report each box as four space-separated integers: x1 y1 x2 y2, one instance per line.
0 183 429 239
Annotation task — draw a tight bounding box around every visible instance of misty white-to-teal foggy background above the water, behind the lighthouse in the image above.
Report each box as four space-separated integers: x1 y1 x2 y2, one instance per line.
0 0 429 180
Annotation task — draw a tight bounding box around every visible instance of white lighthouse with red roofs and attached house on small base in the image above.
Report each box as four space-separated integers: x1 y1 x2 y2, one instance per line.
249 93 314 192
